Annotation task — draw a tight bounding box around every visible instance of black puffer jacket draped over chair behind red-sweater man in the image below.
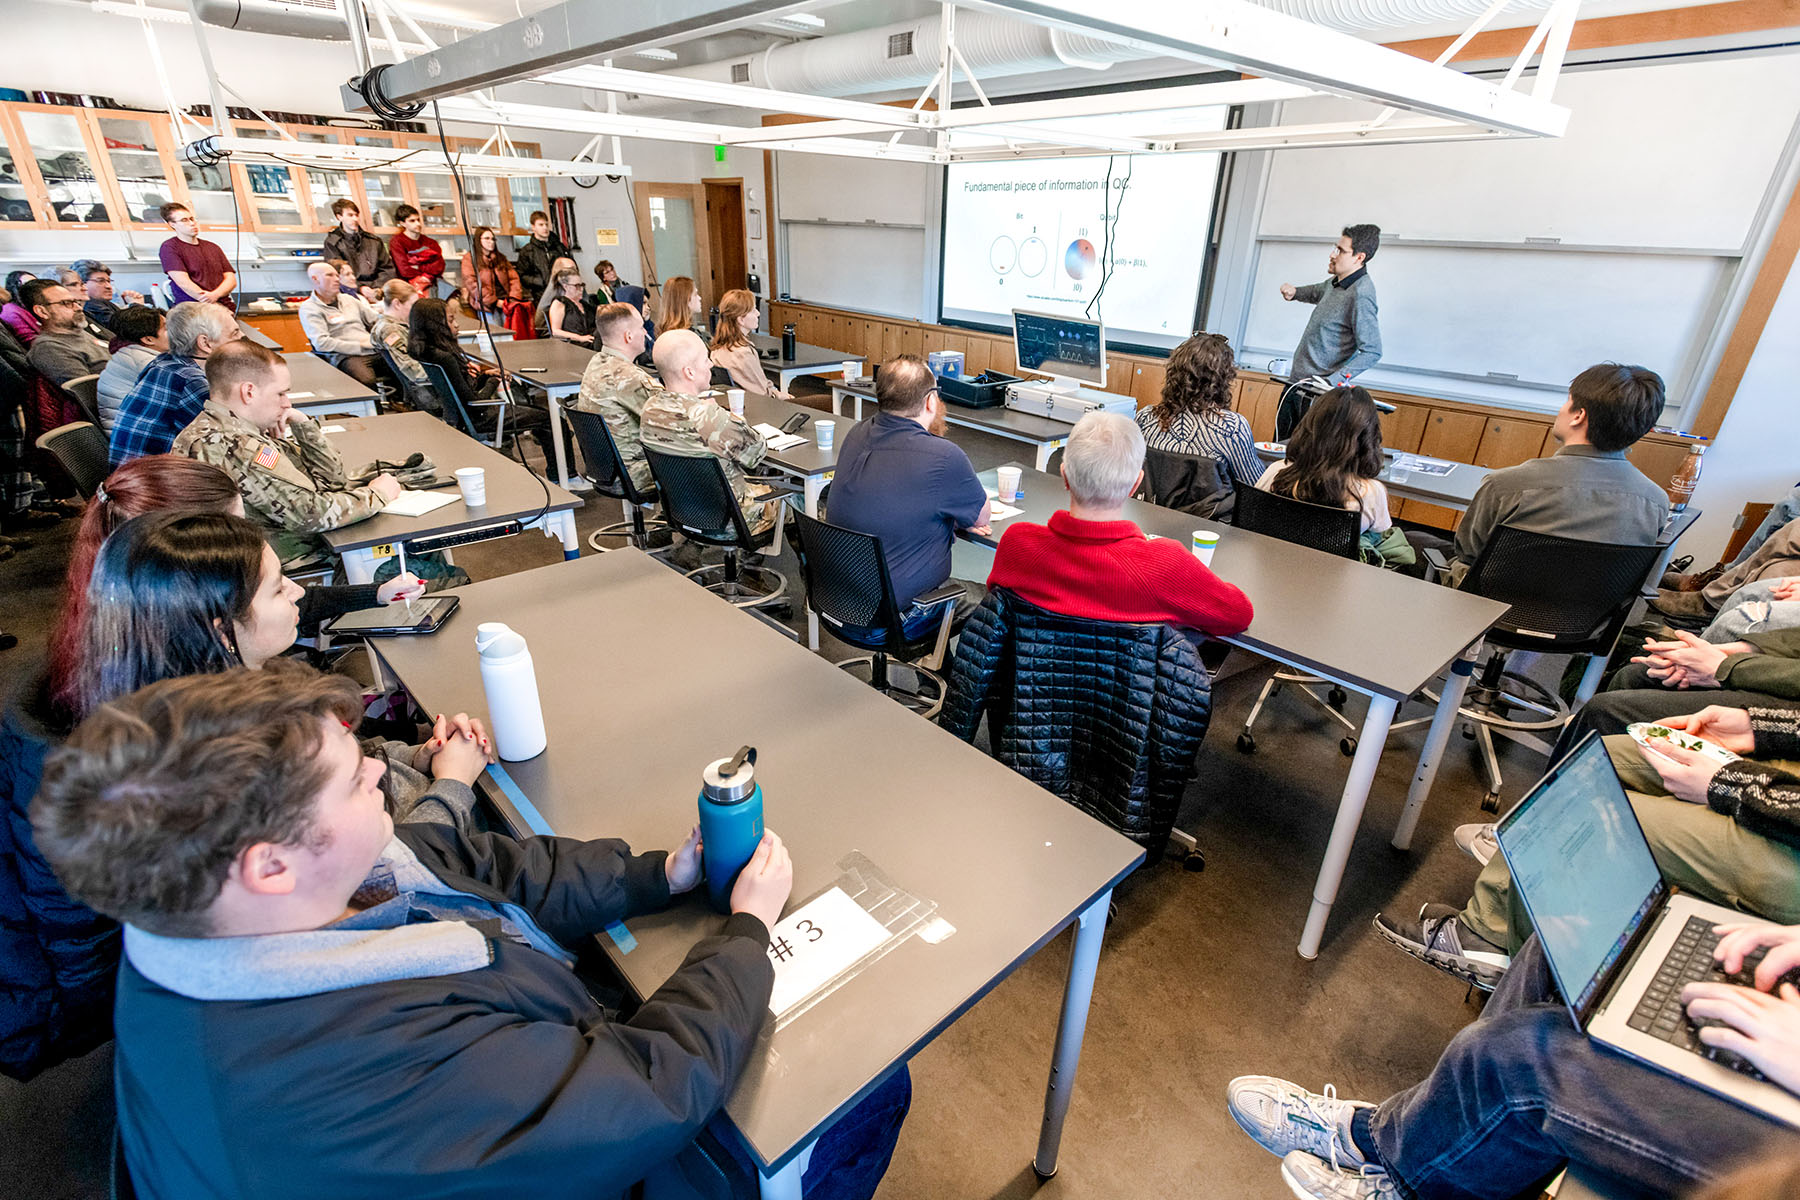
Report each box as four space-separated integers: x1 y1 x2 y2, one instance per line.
938 588 1213 862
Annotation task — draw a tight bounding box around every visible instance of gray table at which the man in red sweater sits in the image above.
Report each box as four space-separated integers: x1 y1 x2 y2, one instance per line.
963 471 1507 959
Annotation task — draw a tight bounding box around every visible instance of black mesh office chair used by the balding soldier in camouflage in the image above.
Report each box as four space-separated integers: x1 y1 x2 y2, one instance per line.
644 446 792 608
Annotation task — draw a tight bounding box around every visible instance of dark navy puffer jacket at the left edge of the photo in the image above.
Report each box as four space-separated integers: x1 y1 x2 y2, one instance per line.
0 684 119 1079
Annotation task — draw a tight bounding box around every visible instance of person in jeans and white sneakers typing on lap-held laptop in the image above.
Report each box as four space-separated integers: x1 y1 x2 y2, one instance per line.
1228 738 1800 1200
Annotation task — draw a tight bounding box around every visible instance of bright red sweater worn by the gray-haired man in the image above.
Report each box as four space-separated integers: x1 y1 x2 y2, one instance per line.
988 511 1253 635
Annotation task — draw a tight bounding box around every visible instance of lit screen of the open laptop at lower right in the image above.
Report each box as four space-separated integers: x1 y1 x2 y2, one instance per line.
1498 734 1667 1024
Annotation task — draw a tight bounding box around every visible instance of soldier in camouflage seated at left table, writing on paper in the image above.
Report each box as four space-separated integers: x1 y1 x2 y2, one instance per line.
173 340 400 563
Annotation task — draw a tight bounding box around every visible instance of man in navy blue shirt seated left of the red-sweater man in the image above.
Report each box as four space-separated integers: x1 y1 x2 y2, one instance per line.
828 354 988 637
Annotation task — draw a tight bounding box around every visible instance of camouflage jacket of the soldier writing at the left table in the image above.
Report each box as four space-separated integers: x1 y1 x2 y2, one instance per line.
171 399 382 563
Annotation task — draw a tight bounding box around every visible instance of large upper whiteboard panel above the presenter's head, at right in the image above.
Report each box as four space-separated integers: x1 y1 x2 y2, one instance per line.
1260 52 1800 257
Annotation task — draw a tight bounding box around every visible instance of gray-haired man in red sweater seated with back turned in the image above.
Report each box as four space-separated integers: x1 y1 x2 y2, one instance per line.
988 412 1253 637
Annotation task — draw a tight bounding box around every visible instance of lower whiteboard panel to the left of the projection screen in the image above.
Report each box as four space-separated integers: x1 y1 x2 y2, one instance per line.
781 225 925 320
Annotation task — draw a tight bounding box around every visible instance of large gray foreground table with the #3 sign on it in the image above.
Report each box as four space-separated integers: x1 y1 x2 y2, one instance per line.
371 549 1143 1200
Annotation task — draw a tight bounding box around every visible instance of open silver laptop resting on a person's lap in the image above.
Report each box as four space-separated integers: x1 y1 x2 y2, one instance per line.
1496 734 1800 1124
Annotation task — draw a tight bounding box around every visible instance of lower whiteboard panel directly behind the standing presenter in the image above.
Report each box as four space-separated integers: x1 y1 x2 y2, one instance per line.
1244 241 1730 390
